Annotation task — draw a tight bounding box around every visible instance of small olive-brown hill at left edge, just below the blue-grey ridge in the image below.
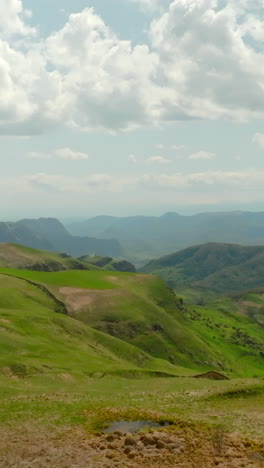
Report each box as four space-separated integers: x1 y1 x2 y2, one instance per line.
0 243 98 271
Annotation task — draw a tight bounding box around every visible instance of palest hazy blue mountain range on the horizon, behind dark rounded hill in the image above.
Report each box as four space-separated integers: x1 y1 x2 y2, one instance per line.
68 211 264 265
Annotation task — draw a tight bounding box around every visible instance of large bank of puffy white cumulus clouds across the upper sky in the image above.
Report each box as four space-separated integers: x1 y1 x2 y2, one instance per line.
0 0 264 135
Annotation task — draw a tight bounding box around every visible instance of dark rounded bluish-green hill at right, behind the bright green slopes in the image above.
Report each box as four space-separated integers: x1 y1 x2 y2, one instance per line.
141 243 264 300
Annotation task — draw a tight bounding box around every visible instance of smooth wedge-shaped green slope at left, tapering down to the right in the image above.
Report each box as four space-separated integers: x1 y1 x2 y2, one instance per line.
0 275 188 381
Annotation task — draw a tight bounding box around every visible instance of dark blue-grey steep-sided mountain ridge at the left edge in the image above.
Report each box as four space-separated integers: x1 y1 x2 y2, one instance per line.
0 218 122 257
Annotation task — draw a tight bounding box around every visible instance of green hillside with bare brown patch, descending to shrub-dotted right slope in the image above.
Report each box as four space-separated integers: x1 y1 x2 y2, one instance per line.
0 269 264 377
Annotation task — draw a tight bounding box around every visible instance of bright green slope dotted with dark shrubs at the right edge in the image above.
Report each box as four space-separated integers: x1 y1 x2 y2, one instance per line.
189 298 264 377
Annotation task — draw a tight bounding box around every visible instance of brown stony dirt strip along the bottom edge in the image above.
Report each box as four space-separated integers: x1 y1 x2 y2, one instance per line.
0 425 264 468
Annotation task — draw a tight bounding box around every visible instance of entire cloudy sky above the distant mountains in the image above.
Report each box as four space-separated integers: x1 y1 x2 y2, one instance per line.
0 0 264 220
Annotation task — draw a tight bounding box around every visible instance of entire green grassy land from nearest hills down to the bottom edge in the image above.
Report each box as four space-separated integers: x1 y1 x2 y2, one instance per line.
0 245 264 468
